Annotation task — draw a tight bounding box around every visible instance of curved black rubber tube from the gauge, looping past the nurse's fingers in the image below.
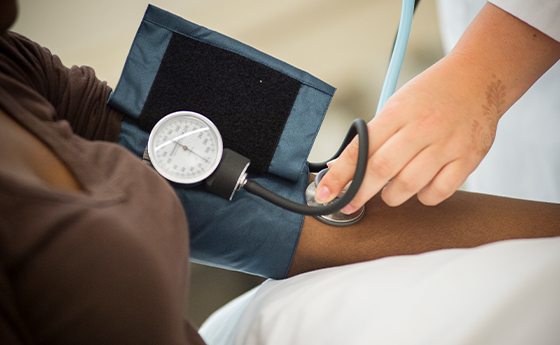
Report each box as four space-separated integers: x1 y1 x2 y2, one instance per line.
243 119 369 216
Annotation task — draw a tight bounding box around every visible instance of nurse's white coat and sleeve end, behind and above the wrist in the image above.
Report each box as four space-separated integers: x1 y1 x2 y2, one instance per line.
438 0 560 202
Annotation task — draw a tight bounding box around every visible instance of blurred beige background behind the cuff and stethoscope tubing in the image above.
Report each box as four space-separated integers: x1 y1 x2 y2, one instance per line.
12 0 443 326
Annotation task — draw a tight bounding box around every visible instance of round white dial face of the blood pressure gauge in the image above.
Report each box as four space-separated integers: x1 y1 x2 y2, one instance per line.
148 111 223 184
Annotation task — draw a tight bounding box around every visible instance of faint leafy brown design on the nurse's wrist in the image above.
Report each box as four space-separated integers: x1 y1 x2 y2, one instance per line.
472 75 506 156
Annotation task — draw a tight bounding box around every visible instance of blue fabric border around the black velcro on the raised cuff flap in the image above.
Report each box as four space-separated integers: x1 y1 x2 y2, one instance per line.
109 5 335 181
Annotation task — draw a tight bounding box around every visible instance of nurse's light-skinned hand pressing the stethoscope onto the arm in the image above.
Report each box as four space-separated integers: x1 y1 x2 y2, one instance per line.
316 54 498 213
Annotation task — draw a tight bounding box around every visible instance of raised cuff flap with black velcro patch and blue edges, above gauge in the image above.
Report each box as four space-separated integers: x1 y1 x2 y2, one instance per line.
109 5 335 181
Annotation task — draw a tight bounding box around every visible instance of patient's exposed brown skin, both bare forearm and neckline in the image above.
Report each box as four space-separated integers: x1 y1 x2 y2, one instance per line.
0 0 560 276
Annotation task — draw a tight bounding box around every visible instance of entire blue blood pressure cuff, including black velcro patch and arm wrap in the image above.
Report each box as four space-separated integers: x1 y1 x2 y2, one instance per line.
109 5 335 278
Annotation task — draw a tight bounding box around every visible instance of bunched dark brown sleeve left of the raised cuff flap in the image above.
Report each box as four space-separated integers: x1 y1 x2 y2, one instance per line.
0 33 123 142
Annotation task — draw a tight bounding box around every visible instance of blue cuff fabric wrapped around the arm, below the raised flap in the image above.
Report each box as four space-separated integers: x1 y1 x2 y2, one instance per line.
118 117 309 279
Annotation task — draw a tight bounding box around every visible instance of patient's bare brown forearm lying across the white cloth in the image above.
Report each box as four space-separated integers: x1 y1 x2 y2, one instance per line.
288 192 560 276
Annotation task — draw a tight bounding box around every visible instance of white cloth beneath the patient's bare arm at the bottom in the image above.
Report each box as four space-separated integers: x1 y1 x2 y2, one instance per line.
200 238 560 345
